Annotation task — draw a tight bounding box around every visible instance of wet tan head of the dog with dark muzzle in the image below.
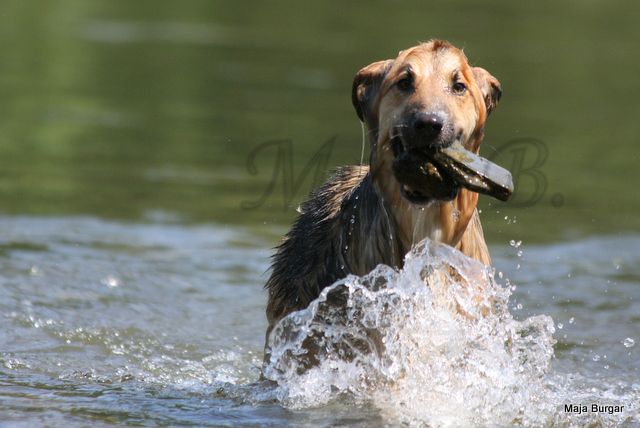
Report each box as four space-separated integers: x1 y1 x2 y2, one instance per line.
352 40 501 204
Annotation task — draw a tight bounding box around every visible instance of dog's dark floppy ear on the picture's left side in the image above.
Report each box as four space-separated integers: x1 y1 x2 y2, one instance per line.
351 59 393 129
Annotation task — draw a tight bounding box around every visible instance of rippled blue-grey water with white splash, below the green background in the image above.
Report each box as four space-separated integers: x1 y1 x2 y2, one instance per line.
0 217 640 426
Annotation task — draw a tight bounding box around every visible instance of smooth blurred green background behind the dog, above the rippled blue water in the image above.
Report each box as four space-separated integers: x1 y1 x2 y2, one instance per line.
0 0 640 242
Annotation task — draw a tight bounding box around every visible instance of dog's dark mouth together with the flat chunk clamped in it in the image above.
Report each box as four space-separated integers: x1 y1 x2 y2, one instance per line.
390 136 513 205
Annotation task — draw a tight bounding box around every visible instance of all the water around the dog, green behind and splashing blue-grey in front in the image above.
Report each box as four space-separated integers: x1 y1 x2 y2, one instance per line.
0 0 640 426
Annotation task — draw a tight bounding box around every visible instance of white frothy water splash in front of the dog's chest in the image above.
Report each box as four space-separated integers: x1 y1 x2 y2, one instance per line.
264 240 555 426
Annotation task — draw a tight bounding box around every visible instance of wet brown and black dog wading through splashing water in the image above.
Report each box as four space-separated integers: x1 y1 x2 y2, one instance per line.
265 40 501 360
